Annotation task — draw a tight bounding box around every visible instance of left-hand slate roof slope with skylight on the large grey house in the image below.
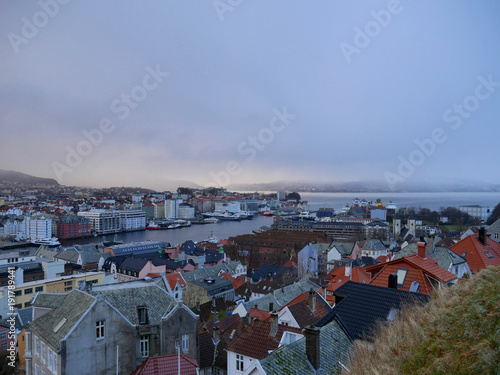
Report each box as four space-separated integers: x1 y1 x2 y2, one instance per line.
30 290 95 348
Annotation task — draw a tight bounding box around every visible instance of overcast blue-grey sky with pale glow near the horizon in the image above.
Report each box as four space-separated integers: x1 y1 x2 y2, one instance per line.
0 0 500 189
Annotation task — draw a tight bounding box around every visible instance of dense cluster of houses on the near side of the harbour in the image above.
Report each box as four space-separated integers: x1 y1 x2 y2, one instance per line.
0 219 500 375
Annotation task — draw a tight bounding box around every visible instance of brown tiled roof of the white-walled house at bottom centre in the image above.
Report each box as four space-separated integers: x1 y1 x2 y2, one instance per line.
226 320 302 359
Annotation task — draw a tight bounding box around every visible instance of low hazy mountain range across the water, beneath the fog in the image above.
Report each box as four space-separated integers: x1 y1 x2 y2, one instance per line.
227 179 500 193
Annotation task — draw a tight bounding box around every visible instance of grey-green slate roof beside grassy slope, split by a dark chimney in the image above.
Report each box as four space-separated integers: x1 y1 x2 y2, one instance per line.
260 319 352 375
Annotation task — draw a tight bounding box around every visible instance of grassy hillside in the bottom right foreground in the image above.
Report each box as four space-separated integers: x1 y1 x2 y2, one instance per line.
349 267 500 375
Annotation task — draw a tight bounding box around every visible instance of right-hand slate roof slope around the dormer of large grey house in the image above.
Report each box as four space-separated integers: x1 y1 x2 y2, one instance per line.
91 278 175 325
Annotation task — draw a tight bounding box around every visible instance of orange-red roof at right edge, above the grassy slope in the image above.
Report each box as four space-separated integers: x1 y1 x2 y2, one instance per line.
450 234 500 273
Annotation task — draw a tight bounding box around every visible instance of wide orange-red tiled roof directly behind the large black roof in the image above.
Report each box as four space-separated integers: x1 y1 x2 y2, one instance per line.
366 254 457 295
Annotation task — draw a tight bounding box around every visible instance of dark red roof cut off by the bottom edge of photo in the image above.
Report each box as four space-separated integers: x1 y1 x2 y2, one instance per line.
132 354 198 375
